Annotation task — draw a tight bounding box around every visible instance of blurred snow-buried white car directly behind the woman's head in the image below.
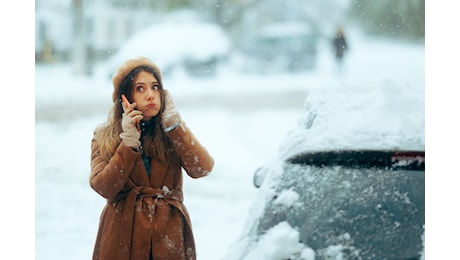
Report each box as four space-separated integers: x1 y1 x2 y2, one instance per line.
105 19 231 77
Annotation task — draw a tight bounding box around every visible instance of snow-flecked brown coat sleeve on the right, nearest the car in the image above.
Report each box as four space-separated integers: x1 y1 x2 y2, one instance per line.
168 121 214 178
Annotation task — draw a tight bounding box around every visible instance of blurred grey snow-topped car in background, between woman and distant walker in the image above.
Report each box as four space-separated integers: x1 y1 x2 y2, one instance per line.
246 22 317 73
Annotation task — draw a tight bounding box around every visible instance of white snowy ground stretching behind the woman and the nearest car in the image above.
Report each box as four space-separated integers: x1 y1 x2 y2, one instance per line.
35 31 425 260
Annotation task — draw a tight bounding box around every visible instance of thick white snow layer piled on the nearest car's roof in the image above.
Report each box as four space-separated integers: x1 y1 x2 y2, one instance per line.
280 78 425 158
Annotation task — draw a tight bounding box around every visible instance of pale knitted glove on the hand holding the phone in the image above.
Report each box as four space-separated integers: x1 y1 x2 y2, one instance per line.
120 103 143 150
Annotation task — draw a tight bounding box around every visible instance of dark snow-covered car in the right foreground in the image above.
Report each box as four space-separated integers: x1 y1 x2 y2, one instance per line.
227 82 425 260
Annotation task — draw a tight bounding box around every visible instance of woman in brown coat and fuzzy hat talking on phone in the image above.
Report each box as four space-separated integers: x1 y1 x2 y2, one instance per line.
90 57 214 260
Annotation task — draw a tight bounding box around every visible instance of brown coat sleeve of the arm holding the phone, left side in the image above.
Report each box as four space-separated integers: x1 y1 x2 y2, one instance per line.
90 129 140 199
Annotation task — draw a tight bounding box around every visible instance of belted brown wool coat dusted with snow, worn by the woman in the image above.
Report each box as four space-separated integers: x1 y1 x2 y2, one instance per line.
90 122 214 260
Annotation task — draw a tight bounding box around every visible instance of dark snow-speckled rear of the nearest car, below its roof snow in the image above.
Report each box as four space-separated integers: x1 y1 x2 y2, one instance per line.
256 151 425 259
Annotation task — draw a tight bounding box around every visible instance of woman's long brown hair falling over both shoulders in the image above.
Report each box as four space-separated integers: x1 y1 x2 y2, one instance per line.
95 65 173 162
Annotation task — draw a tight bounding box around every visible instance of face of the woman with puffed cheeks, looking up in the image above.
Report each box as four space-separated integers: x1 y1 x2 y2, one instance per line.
131 70 161 120
